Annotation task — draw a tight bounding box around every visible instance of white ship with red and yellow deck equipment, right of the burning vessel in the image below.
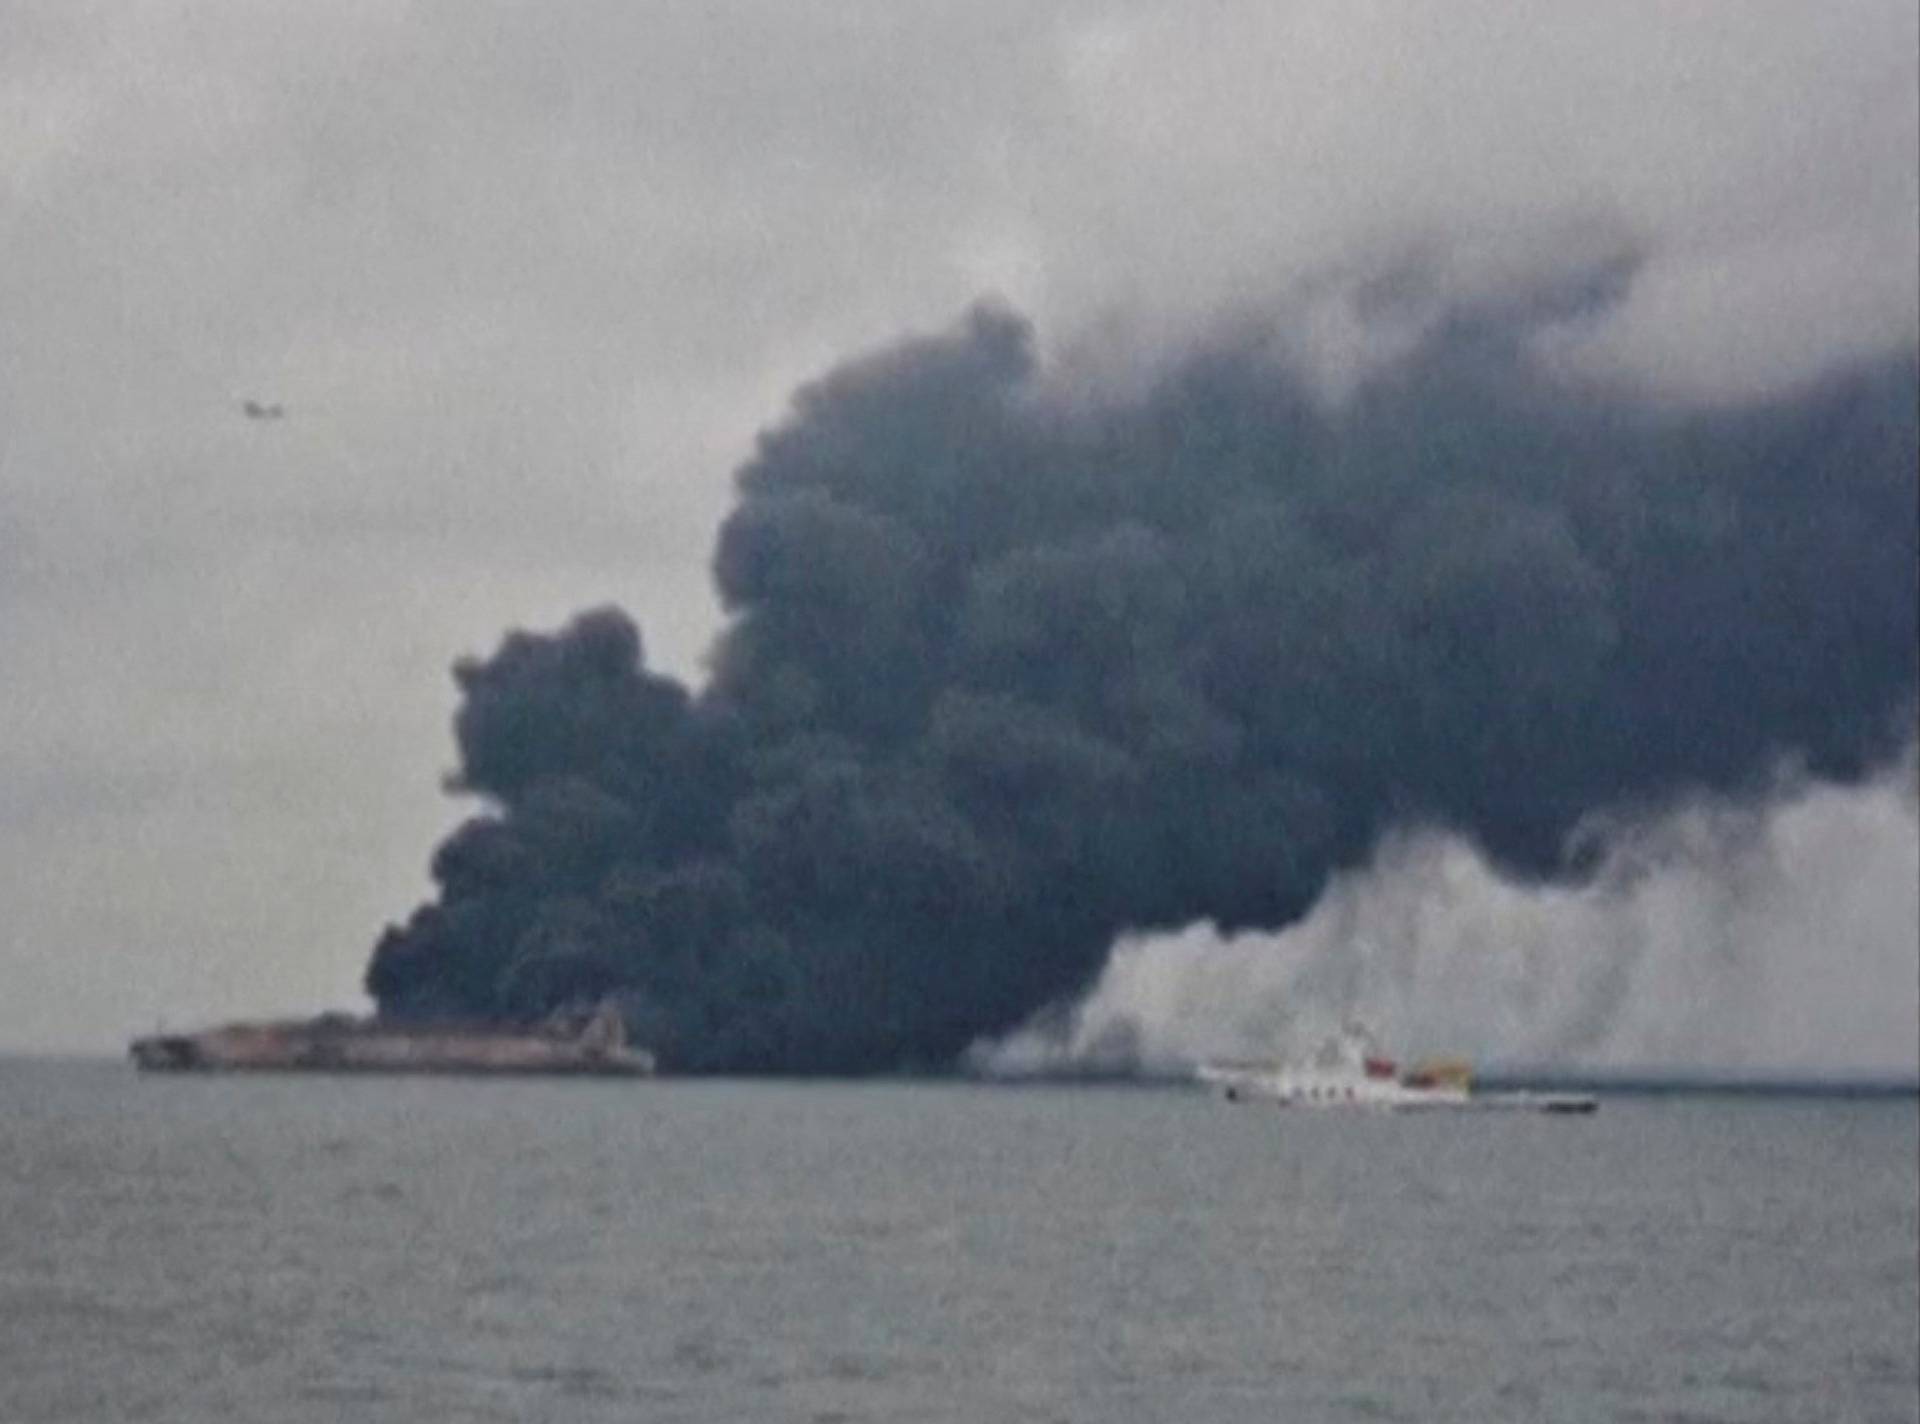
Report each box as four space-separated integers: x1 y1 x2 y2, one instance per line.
1196 1025 1599 1113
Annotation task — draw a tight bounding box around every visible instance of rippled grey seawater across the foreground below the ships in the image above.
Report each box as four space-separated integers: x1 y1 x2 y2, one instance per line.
0 1063 1920 1424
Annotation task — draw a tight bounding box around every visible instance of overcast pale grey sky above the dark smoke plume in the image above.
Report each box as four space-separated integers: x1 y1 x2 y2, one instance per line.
0 0 1920 1052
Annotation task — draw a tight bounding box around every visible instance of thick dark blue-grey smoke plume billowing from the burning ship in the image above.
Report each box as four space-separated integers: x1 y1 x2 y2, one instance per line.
367 282 1920 1071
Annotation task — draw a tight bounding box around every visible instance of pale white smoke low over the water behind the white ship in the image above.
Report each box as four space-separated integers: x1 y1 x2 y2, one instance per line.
973 756 1920 1077
